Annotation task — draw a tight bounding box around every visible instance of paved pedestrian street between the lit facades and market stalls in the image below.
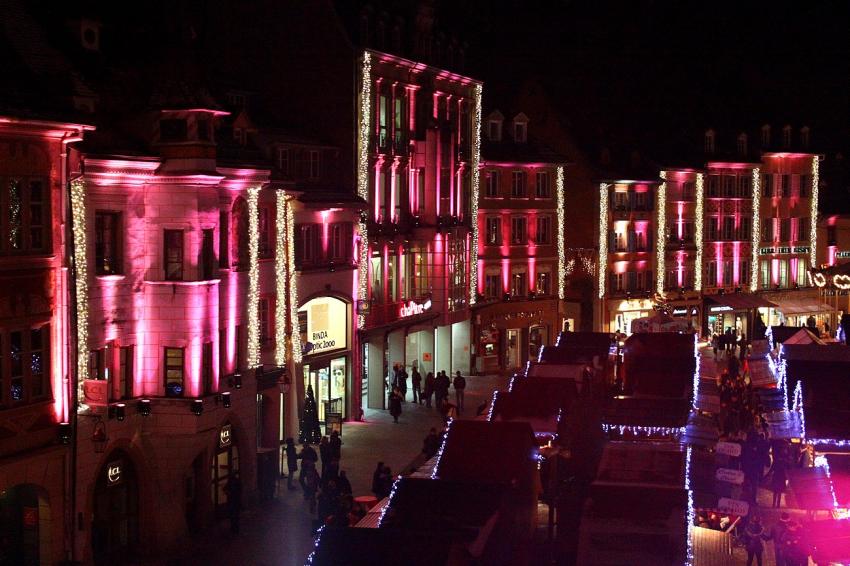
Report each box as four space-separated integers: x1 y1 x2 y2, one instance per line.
157 375 507 566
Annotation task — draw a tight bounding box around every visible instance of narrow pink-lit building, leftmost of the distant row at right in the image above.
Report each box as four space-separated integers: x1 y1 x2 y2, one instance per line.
597 179 665 334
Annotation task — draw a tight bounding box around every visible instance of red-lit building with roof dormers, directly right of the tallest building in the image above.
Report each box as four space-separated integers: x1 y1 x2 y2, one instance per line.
472 110 576 373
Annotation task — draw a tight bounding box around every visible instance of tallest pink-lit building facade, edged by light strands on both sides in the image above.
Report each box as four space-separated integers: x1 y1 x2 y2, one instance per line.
357 51 481 408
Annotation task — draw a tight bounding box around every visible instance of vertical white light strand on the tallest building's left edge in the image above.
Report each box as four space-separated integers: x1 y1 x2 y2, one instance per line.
357 51 372 328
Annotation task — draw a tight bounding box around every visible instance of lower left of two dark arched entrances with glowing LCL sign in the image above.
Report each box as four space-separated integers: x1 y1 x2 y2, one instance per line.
91 450 139 564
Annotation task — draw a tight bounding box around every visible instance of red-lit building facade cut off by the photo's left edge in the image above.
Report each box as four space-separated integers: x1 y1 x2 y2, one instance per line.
0 116 93 564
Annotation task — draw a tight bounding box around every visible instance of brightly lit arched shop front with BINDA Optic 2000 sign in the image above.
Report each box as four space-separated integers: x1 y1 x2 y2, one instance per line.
298 296 352 422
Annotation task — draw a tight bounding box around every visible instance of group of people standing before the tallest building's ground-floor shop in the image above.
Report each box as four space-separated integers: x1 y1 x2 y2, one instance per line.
386 364 466 423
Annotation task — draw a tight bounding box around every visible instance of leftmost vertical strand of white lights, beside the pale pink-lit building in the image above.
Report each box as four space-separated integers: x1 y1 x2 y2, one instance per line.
69 179 89 409
